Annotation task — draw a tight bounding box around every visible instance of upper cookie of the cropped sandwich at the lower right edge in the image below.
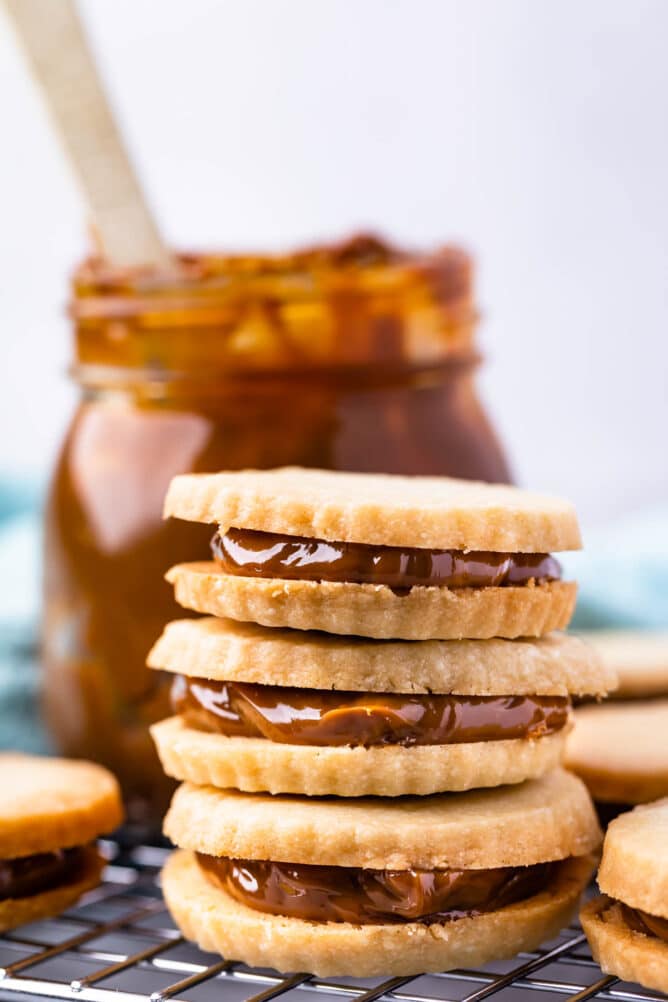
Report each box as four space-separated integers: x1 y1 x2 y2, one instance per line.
598 797 668 919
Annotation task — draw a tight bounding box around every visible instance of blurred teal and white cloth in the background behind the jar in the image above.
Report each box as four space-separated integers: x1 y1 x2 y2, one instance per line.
0 478 668 753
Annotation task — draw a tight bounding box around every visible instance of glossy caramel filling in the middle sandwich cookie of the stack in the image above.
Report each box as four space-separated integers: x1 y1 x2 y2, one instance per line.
171 675 570 746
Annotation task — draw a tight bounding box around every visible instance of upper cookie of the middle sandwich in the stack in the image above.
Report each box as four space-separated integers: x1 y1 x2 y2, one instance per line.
148 617 615 695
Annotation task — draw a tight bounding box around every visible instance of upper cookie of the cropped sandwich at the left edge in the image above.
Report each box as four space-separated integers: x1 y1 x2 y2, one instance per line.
0 752 123 859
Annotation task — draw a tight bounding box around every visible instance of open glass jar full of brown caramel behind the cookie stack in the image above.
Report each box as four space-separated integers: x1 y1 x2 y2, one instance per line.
44 230 509 826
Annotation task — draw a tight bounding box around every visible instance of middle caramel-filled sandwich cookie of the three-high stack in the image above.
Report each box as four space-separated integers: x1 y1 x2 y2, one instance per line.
148 618 615 797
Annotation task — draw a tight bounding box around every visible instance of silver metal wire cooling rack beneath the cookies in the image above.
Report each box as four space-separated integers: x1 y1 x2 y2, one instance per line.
0 843 665 1002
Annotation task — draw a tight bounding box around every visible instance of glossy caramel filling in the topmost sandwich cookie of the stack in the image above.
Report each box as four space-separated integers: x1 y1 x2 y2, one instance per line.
211 528 561 588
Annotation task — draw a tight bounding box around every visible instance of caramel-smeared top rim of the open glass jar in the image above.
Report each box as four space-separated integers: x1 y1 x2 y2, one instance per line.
69 233 473 318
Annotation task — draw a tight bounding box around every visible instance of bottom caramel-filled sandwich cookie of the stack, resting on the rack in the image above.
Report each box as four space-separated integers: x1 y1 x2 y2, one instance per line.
162 771 600 977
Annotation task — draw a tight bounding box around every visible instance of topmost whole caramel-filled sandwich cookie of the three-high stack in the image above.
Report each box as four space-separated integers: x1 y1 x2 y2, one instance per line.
164 468 581 640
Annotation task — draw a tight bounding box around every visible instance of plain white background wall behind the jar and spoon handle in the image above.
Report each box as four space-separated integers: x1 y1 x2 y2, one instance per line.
0 0 668 522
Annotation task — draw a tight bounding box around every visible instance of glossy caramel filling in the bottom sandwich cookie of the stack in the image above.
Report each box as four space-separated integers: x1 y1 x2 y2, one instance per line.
197 853 555 925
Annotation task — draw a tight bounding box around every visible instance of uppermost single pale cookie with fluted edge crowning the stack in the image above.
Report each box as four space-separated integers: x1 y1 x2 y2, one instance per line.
164 467 582 553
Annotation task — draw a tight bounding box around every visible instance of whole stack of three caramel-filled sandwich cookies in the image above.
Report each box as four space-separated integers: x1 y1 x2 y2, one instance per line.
149 469 614 976
